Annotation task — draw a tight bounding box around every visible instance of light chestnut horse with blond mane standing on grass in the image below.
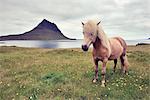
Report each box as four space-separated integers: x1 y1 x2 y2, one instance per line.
82 20 129 87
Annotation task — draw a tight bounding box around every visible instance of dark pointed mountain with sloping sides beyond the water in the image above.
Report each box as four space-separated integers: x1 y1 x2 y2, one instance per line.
0 19 74 41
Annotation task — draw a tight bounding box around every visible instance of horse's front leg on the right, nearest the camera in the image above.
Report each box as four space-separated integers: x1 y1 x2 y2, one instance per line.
101 59 107 87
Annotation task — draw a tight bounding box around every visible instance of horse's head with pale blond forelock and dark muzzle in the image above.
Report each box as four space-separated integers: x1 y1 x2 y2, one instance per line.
82 21 100 51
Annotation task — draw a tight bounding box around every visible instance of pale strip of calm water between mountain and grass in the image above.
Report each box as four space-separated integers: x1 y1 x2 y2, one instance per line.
0 39 150 48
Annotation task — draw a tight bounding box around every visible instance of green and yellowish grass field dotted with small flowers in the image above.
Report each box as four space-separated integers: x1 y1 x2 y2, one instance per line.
0 45 150 100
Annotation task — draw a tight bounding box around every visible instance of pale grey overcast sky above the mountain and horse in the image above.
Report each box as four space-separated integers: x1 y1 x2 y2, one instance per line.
0 0 150 39
